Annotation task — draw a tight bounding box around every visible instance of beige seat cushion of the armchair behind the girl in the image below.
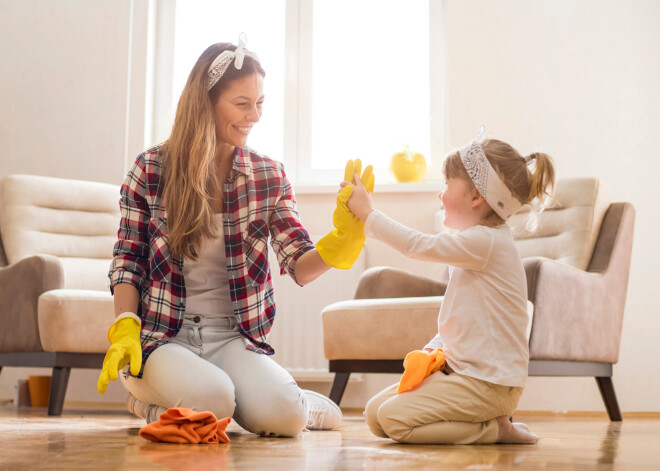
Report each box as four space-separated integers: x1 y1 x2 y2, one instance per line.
321 296 444 360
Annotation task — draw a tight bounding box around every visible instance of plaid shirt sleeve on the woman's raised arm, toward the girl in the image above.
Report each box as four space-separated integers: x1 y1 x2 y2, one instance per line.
270 167 314 283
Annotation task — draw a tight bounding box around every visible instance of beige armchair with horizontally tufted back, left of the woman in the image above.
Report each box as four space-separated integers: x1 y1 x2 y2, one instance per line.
0 175 119 415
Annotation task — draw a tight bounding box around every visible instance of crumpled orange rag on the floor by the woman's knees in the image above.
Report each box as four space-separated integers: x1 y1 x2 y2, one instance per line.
140 407 231 444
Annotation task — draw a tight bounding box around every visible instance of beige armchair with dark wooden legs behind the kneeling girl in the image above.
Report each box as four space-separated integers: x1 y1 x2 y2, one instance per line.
321 178 634 421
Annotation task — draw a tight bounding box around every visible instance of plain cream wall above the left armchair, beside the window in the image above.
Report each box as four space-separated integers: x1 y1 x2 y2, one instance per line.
0 0 147 184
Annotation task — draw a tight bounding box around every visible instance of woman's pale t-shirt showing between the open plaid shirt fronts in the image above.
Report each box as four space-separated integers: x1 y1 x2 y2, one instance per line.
183 213 234 316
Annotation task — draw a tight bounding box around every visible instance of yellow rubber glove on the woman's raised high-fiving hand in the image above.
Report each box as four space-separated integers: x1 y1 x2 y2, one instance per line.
316 159 375 269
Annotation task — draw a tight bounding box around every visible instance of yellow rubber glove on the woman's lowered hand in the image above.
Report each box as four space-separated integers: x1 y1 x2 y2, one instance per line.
97 317 142 394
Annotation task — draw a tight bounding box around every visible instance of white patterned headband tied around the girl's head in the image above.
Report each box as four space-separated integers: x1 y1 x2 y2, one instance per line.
458 126 522 221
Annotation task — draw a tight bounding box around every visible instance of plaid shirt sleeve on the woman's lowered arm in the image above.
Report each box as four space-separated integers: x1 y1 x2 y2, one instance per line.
108 155 151 293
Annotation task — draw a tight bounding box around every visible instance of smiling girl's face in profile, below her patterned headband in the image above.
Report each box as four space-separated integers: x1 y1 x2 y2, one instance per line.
438 178 480 231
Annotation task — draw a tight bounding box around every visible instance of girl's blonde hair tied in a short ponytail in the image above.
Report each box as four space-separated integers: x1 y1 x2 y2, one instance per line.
442 139 555 227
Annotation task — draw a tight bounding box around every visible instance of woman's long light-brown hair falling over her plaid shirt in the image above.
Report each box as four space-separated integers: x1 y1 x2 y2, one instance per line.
161 43 265 260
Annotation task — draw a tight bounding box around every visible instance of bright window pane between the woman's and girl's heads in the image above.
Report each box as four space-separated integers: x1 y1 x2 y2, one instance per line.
308 0 429 180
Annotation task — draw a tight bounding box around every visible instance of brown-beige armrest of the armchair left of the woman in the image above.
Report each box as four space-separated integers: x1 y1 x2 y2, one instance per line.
0 255 64 353
